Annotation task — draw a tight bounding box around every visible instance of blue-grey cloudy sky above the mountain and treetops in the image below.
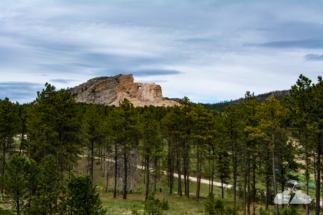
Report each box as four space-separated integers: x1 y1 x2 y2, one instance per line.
0 0 323 103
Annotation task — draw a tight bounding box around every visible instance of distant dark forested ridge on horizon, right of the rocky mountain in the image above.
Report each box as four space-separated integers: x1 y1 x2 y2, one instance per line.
200 90 289 112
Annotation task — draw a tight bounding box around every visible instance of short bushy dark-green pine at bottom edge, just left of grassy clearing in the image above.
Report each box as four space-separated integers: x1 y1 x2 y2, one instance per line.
66 172 106 215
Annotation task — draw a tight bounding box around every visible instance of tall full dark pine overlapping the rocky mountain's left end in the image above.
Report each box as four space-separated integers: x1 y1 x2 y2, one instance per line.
27 83 81 180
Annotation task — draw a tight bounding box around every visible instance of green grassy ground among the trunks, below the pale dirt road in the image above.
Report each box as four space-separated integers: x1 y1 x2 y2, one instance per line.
76 158 315 215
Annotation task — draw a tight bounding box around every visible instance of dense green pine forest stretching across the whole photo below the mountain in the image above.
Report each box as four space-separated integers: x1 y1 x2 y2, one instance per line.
0 75 323 215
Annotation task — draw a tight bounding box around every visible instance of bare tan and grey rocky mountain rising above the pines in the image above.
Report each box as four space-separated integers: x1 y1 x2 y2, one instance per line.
71 75 179 107
